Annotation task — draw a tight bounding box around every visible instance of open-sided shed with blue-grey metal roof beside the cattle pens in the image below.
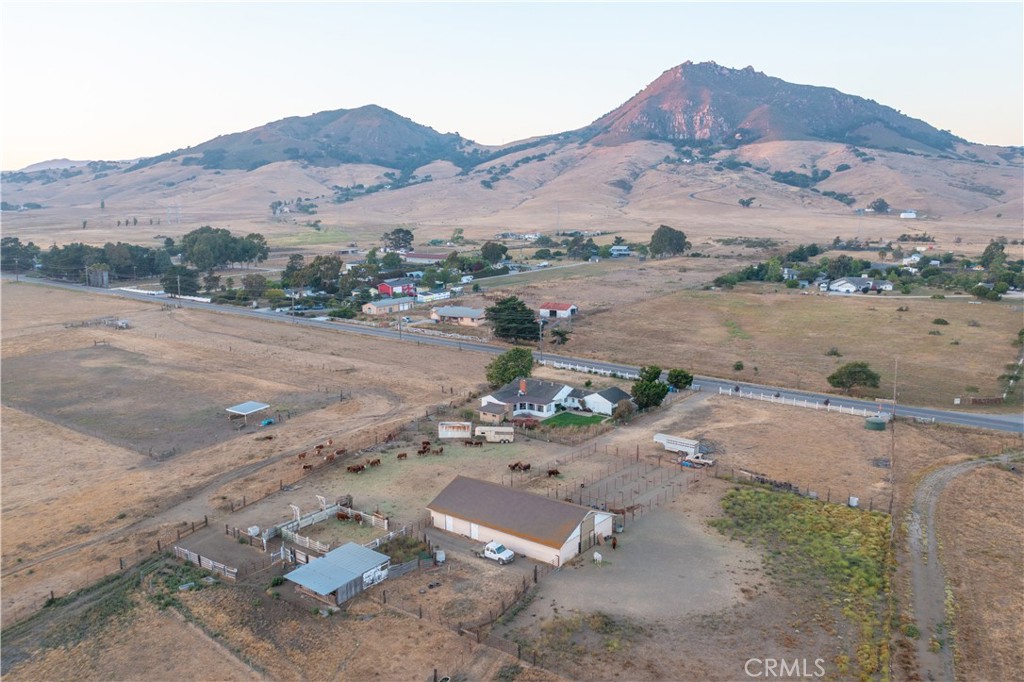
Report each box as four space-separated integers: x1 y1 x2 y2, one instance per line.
285 543 391 605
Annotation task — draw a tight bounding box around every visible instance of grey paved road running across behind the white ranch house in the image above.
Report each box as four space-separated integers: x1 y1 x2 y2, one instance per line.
14 282 1024 433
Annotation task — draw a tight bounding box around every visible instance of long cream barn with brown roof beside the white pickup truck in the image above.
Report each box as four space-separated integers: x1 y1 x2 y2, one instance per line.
427 476 613 566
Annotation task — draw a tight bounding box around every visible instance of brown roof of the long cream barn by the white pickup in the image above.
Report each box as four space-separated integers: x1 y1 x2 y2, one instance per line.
427 476 591 549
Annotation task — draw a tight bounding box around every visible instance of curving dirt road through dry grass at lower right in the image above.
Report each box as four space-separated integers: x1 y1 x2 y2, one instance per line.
906 448 1009 680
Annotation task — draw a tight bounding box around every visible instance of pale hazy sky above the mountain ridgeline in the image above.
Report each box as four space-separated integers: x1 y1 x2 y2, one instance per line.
0 0 1024 170
